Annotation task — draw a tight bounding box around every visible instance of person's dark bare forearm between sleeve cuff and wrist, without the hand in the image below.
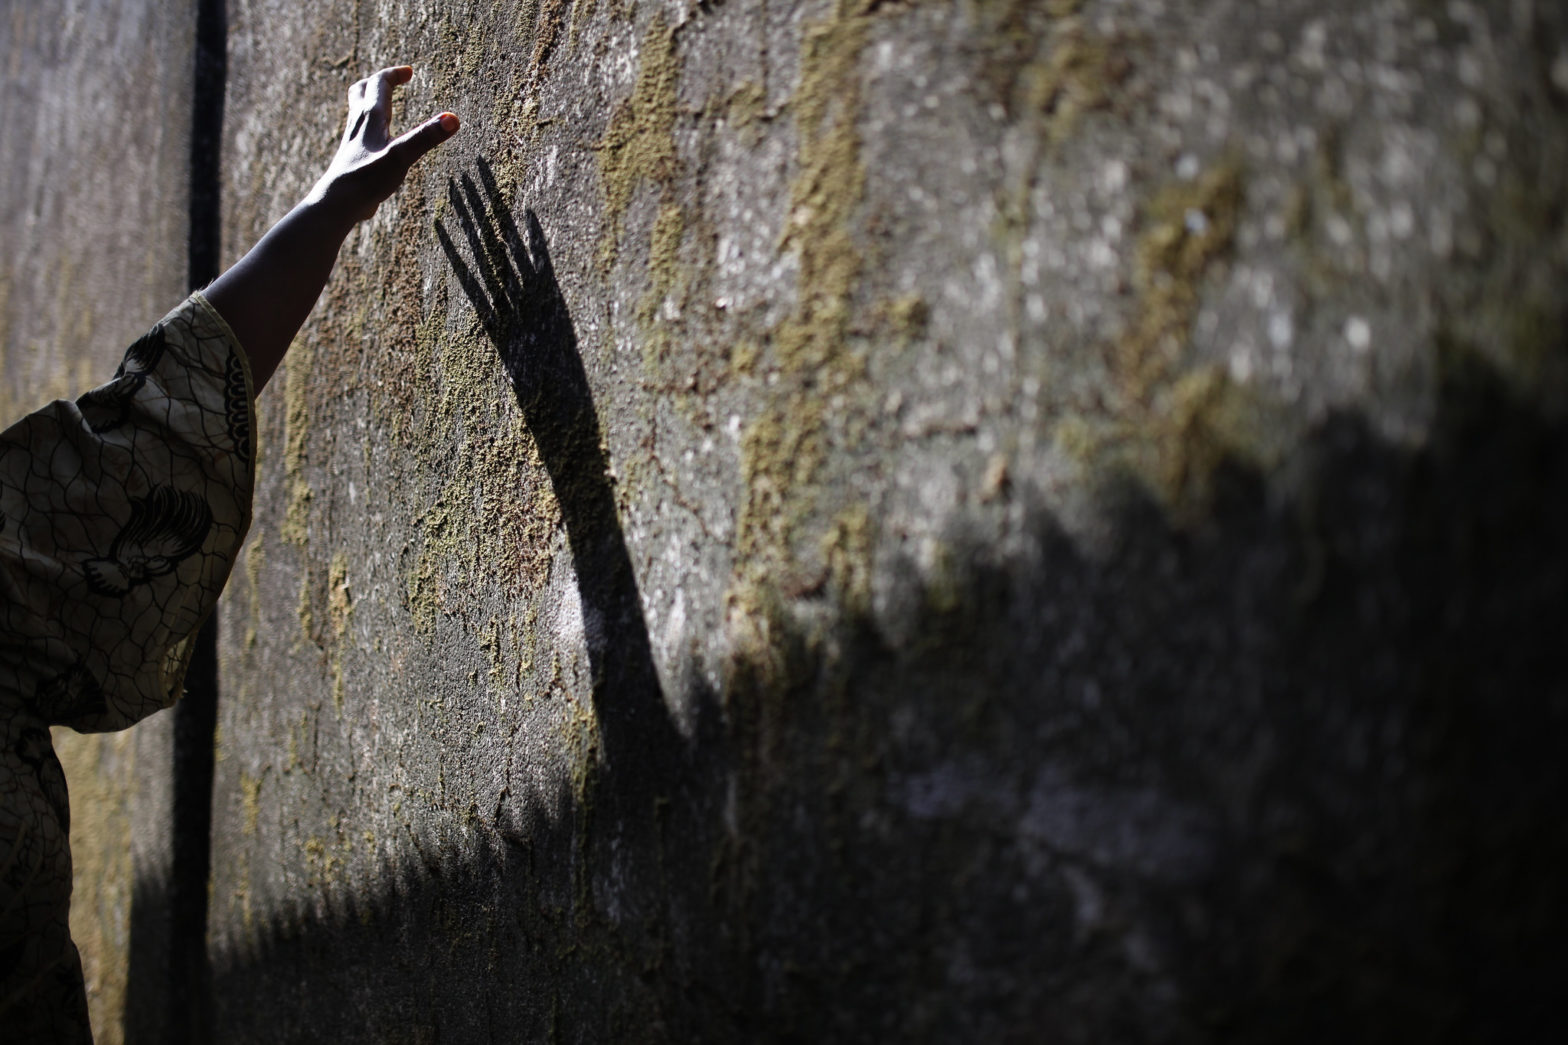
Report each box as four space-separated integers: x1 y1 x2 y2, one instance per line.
207 193 354 391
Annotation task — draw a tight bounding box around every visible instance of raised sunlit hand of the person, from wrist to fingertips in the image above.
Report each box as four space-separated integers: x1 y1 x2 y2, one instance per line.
306 66 459 224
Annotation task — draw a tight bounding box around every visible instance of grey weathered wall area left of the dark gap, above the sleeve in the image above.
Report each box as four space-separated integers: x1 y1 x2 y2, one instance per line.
0 0 191 421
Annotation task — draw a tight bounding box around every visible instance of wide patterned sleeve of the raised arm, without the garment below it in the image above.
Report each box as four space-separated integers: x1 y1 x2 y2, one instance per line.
0 293 256 731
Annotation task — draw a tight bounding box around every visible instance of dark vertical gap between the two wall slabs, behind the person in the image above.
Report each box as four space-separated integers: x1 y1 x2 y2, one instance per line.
166 0 227 1045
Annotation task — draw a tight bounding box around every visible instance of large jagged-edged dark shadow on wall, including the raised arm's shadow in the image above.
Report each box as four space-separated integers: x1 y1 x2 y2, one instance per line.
199 192 1568 1042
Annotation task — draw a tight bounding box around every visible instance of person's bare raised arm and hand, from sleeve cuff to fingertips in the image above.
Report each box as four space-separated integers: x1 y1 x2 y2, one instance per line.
205 66 458 391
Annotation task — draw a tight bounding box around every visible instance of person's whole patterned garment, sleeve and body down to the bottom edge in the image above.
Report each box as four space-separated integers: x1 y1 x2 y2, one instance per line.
0 293 256 1042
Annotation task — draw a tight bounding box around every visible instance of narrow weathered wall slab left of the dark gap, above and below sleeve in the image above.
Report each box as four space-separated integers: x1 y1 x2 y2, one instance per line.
0 0 191 1043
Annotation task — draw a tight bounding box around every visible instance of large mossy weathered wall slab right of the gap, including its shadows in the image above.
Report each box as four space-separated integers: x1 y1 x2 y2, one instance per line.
212 0 1568 1042
